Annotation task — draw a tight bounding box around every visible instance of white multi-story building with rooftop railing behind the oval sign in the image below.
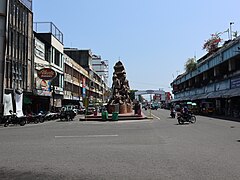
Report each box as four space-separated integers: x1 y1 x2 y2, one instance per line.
34 22 64 109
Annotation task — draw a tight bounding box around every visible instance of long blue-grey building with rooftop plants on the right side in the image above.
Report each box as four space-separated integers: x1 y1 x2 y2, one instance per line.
171 37 240 117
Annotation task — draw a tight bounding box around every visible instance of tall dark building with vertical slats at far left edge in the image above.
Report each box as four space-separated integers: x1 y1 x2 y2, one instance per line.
0 0 33 114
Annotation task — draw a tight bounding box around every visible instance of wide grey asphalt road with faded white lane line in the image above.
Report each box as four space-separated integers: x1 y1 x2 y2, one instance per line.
0 109 240 180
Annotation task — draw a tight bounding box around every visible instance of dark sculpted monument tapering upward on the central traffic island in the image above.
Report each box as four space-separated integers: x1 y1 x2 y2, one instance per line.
108 61 132 114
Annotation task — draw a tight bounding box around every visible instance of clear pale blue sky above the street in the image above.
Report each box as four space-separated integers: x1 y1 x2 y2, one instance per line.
33 0 240 91
